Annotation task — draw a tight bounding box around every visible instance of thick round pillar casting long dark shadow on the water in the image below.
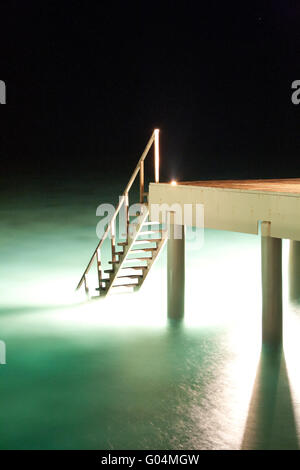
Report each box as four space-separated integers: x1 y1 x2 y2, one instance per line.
261 222 282 346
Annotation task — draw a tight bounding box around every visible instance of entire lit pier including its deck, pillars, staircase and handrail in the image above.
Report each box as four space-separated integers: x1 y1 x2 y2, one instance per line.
77 129 300 345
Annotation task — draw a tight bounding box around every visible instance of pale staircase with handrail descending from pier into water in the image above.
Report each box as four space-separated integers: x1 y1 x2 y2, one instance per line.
76 129 167 299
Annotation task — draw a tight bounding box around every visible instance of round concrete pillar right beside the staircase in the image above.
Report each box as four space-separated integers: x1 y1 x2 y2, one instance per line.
167 218 185 318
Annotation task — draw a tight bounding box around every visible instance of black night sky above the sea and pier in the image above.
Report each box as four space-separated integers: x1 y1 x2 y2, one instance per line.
0 0 300 180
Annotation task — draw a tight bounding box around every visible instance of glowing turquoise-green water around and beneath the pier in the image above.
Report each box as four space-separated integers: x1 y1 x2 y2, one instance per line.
0 177 300 449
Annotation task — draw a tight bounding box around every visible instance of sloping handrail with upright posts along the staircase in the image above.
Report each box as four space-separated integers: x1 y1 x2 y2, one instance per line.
76 129 159 292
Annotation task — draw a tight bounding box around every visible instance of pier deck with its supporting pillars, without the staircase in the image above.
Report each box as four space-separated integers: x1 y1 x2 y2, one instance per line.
149 179 300 344
